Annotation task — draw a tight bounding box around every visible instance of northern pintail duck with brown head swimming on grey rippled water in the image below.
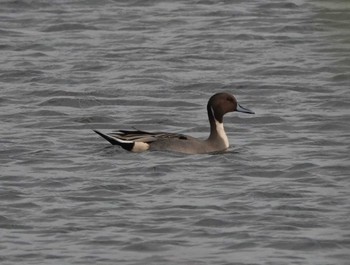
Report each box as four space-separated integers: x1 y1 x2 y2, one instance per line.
94 93 254 154
